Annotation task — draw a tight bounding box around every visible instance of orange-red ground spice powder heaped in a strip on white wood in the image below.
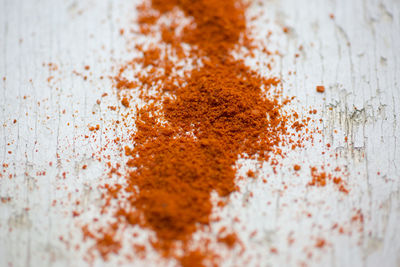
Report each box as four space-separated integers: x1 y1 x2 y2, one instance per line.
80 0 340 266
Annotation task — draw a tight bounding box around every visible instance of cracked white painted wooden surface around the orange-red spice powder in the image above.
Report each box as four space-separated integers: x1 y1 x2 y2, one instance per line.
0 0 400 267
